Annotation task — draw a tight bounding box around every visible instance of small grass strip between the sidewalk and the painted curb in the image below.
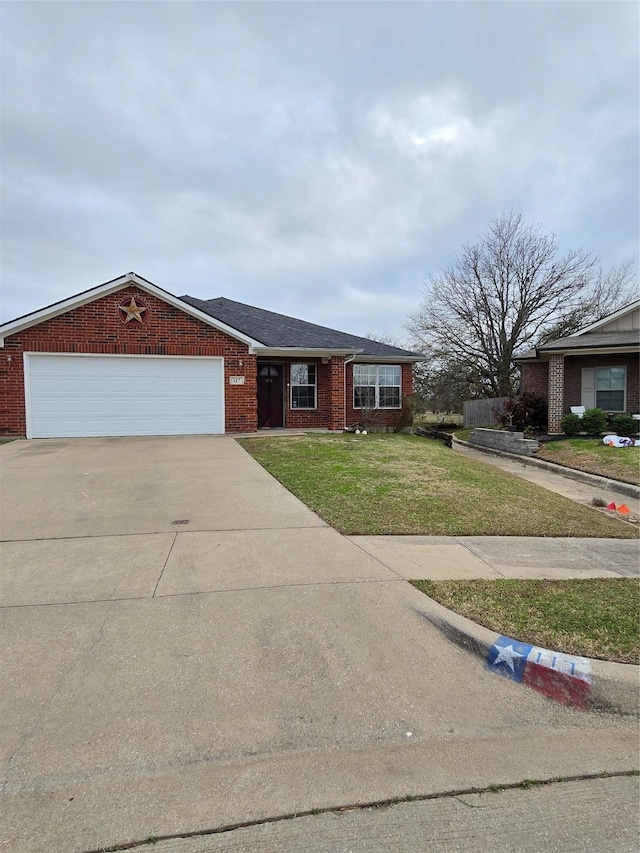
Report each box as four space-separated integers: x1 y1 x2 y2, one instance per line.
411 578 640 663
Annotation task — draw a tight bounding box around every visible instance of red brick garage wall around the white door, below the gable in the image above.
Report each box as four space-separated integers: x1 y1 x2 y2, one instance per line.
0 286 258 436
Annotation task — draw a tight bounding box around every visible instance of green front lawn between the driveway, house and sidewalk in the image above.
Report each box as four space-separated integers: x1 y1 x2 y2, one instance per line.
240 433 637 538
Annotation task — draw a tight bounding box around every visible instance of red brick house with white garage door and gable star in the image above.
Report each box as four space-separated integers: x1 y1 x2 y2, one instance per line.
0 273 420 438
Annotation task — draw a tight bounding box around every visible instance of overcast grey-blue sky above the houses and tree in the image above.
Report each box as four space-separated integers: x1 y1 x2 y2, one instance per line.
1 0 639 337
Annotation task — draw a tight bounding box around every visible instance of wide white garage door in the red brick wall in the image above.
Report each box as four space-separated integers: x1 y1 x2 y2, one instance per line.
25 354 224 438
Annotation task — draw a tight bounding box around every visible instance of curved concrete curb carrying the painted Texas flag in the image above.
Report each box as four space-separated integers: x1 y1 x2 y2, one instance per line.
416 593 640 717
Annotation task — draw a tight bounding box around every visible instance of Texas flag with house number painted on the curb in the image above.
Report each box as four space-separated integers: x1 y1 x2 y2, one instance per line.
487 637 591 710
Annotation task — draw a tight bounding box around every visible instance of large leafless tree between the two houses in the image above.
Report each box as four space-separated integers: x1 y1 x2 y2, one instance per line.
408 212 633 396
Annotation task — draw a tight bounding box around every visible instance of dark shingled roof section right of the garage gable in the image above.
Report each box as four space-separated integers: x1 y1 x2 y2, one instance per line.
180 296 420 359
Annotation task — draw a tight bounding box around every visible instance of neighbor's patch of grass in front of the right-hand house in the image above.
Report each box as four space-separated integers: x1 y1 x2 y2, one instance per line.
536 438 640 486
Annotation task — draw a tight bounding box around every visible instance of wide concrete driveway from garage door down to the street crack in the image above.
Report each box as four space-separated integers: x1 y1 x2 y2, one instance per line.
0 437 637 853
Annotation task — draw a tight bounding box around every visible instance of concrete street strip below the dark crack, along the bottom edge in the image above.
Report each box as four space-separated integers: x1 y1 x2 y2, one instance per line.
116 776 640 853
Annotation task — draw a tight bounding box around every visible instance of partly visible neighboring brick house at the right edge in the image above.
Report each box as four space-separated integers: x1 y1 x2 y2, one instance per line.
515 300 640 434
